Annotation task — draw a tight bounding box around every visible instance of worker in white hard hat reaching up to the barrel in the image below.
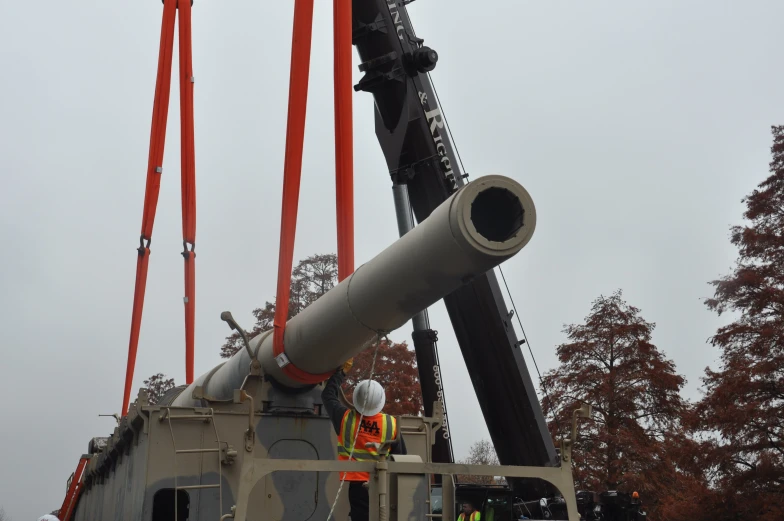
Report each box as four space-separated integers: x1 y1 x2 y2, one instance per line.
321 360 406 521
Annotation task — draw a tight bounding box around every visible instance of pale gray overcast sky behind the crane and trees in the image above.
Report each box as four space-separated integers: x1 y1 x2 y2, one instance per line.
0 0 784 521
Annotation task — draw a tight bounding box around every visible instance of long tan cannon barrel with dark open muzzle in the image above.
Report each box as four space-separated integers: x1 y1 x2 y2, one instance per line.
174 175 536 405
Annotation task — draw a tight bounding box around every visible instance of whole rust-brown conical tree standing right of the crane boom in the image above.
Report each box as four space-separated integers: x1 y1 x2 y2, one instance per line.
543 291 685 515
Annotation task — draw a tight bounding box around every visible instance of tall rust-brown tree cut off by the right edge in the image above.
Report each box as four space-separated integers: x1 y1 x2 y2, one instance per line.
695 126 784 521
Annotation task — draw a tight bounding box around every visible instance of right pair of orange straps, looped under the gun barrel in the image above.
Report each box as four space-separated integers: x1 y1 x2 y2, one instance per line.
273 0 354 384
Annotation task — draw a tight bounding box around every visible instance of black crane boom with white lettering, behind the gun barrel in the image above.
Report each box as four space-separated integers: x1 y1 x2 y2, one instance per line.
353 0 558 490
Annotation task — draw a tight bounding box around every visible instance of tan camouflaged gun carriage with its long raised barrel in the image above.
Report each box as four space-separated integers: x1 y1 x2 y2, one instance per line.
67 176 578 521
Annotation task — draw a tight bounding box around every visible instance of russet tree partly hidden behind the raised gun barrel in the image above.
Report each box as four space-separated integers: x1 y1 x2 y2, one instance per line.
221 253 423 415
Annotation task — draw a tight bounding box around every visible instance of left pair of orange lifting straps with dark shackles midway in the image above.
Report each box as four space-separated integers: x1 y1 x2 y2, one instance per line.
122 0 196 415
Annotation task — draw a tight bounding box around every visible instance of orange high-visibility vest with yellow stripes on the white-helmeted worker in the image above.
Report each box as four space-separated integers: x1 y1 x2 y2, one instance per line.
338 409 397 481
